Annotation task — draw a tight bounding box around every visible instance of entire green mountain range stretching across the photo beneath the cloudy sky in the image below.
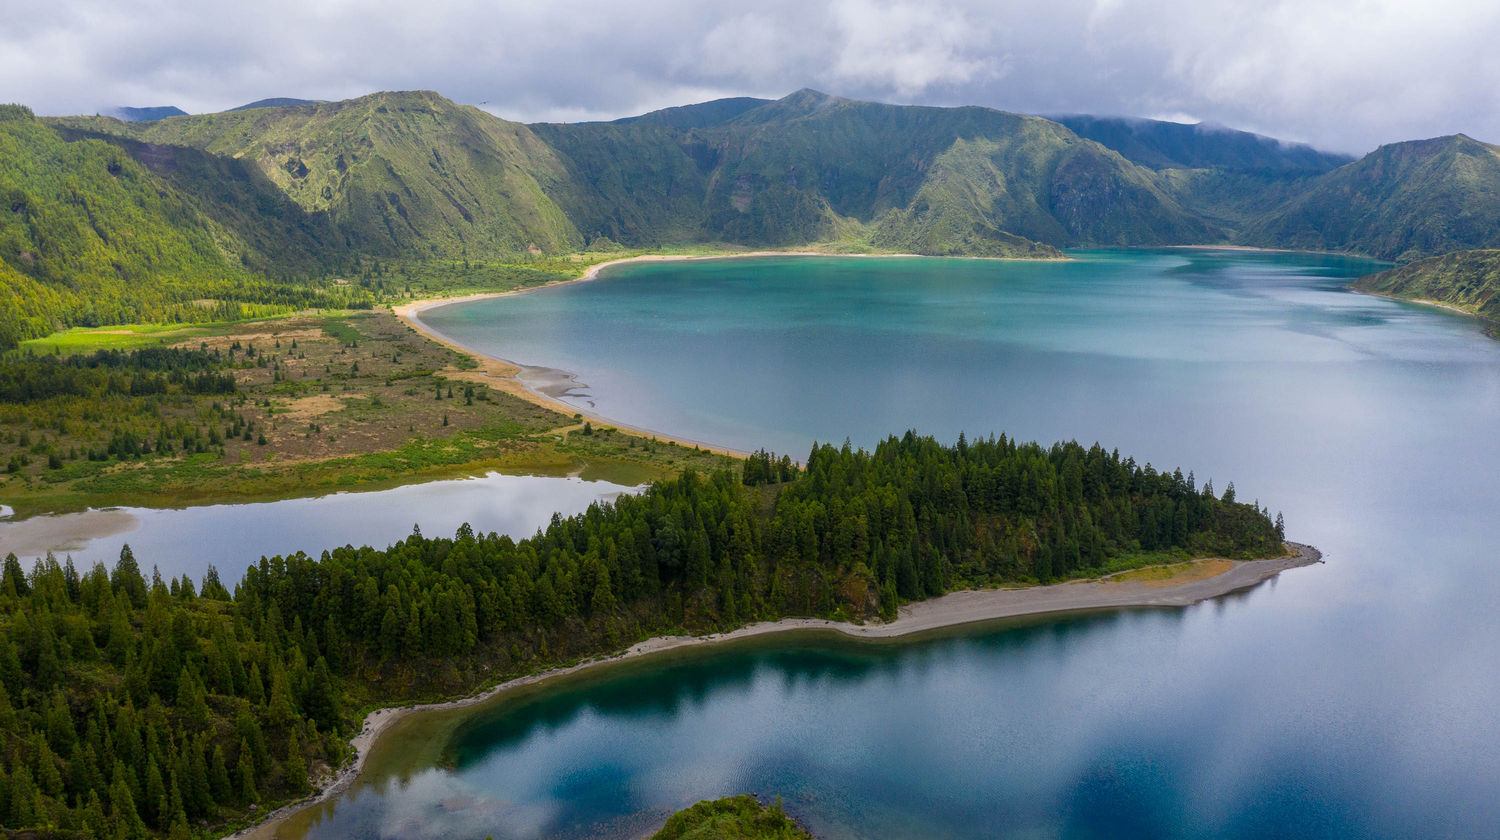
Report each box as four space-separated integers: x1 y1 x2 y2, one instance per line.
17 90 1500 344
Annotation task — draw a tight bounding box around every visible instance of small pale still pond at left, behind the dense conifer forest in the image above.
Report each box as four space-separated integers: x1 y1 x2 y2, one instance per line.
0 473 632 588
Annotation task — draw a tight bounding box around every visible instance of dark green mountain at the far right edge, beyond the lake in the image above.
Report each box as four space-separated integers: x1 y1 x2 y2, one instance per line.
1244 135 1500 261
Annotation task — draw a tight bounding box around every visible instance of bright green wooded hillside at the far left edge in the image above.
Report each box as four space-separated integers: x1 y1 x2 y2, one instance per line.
0 105 343 350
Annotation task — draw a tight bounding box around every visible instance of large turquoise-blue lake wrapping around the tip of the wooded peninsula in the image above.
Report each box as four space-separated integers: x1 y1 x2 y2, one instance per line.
325 251 1500 840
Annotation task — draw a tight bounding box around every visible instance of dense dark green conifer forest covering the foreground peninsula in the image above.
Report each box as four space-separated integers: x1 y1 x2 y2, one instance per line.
0 432 1281 839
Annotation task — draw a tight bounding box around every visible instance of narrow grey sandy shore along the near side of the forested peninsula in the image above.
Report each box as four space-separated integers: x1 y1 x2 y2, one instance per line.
225 542 1323 840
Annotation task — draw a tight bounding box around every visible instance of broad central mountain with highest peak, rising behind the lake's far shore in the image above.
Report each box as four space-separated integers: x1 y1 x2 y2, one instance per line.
533 90 1220 257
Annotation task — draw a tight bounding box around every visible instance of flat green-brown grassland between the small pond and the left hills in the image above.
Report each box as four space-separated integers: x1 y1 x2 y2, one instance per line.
0 311 725 516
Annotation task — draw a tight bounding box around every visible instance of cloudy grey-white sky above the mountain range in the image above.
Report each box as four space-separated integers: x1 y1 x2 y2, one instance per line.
0 0 1500 152
